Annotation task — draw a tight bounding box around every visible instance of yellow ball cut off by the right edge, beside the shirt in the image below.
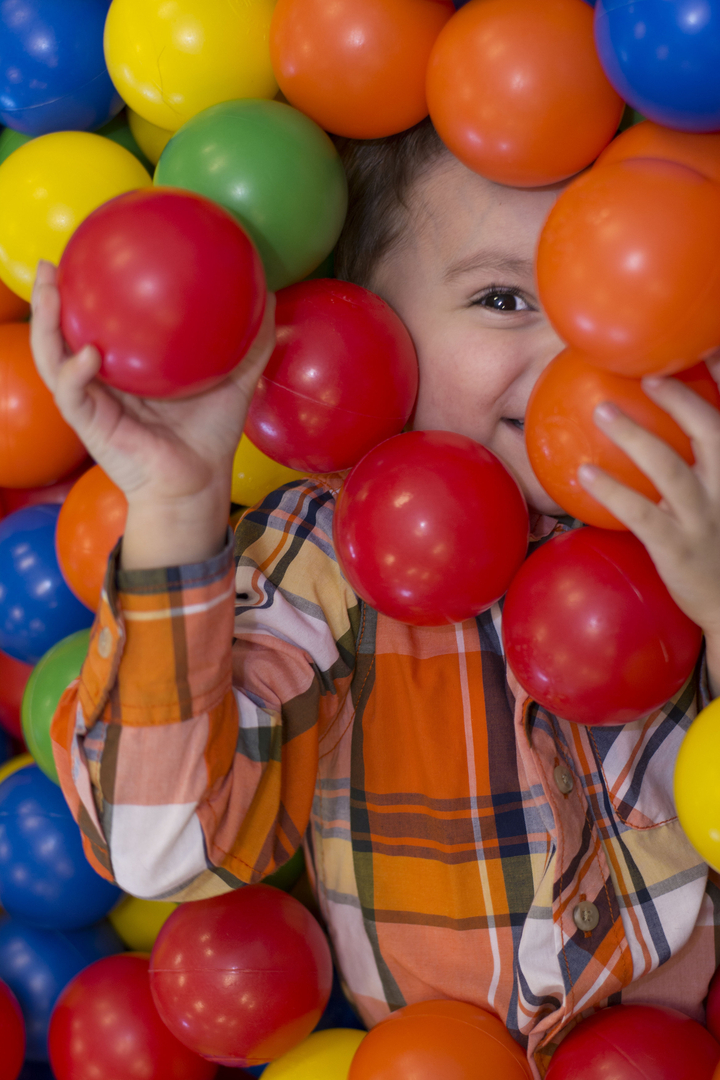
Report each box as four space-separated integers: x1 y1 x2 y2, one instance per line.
675 698 720 872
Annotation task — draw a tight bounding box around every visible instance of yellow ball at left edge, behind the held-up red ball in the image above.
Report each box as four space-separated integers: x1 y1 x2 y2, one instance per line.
0 132 152 300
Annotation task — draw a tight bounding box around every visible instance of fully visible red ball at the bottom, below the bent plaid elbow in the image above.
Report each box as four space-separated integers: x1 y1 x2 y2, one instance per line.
150 885 332 1066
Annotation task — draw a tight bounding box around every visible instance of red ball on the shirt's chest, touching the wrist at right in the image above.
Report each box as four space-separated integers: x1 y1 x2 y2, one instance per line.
503 526 702 724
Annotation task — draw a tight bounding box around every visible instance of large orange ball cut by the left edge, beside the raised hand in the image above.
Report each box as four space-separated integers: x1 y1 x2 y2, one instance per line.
0 323 87 487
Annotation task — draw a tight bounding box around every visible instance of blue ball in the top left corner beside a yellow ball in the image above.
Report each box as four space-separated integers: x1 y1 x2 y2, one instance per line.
0 0 123 135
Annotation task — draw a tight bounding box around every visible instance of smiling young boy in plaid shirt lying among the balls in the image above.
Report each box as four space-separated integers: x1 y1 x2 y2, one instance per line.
32 121 720 1077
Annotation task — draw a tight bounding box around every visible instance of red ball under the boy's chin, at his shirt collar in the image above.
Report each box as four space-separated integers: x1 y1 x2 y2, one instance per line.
332 431 528 626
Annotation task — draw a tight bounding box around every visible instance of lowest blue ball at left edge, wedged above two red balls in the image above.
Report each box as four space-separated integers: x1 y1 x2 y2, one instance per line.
0 917 124 1062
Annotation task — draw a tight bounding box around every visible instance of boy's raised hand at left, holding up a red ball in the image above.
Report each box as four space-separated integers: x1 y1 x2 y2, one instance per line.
30 262 275 566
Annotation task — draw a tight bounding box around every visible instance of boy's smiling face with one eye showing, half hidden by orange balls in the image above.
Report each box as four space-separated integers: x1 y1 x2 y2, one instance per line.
372 156 562 514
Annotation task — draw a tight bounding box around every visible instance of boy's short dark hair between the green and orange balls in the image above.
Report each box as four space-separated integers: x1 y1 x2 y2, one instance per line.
335 117 448 287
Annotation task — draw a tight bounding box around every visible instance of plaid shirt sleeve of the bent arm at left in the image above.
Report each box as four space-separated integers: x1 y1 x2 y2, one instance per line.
51 481 357 900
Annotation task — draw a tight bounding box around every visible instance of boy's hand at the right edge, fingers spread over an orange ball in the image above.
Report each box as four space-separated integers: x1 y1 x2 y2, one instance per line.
579 363 720 697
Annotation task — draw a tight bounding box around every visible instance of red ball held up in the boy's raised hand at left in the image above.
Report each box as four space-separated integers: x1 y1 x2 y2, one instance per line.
57 188 267 397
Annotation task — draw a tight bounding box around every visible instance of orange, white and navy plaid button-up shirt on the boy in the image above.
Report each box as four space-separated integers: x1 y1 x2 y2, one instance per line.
52 481 720 1077
